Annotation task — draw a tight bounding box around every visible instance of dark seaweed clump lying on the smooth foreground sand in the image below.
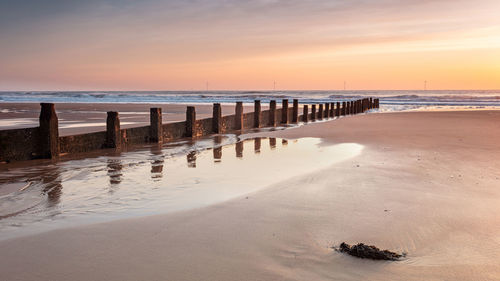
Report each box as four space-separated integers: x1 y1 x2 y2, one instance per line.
336 242 406 261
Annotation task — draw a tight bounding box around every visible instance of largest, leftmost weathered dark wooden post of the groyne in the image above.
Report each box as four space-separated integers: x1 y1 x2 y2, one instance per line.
38 103 59 158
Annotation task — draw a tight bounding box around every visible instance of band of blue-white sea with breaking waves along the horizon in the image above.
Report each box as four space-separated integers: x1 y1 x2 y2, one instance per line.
0 90 500 111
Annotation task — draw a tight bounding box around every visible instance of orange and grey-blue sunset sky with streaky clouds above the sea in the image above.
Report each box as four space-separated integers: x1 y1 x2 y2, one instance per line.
0 0 500 91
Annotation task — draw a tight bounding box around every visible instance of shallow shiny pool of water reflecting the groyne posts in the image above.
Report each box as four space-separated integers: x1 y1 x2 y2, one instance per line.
0 136 362 239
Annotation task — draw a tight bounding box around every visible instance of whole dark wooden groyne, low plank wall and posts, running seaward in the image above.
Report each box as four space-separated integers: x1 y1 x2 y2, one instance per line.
0 98 379 162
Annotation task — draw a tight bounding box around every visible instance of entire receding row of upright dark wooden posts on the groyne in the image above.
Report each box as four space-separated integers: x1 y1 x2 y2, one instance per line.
22 98 379 158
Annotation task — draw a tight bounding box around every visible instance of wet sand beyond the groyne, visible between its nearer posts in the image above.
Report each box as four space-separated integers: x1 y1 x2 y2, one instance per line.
0 103 258 136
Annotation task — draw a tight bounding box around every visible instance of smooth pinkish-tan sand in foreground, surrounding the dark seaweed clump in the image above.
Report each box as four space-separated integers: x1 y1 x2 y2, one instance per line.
0 111 500 280
